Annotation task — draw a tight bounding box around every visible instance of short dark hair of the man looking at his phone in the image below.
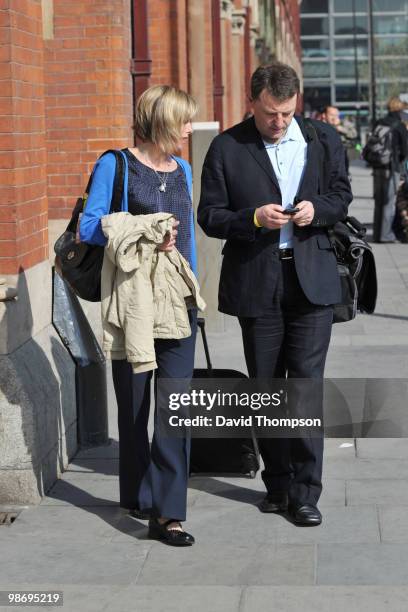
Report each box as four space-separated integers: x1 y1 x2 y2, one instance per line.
251 62 300 101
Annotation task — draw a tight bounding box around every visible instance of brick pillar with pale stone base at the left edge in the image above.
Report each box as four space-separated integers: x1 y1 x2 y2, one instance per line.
0 0 76 505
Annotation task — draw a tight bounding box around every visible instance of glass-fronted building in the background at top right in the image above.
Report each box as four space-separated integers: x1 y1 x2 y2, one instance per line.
300 0 408 125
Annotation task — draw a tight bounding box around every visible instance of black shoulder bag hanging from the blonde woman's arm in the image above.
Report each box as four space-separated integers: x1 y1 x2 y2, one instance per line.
54 149 125 302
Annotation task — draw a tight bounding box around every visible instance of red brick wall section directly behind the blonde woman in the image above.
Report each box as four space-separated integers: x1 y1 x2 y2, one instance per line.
45 0 133 218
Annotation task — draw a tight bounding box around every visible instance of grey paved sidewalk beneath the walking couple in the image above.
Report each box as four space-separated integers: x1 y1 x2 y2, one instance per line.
0 165 408 612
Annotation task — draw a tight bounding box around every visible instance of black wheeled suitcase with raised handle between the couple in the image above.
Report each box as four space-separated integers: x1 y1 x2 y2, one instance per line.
190 318 259 478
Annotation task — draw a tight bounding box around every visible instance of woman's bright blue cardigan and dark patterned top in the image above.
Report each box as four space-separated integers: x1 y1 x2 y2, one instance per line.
80 149 197 273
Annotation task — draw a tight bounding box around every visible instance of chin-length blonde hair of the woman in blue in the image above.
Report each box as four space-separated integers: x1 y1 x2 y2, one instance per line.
135 85 198 155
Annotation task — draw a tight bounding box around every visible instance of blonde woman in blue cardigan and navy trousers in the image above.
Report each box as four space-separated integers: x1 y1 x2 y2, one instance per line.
80 86 197 546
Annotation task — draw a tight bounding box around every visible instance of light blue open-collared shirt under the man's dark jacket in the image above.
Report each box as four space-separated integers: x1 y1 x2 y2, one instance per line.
264 118 307 249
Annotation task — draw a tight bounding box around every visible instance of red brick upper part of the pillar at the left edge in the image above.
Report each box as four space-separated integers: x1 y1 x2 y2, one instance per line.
0 0 48 274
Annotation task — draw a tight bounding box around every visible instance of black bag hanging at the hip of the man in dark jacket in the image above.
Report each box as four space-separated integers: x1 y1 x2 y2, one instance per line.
327 217 377 323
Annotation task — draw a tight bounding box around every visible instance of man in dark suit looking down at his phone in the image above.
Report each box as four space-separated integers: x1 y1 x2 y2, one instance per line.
198 62 352 525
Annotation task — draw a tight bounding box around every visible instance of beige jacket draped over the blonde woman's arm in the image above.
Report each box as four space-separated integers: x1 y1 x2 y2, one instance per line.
101 212 205 373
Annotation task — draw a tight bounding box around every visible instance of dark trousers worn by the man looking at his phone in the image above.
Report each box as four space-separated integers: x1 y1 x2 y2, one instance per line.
239 259 333 505
